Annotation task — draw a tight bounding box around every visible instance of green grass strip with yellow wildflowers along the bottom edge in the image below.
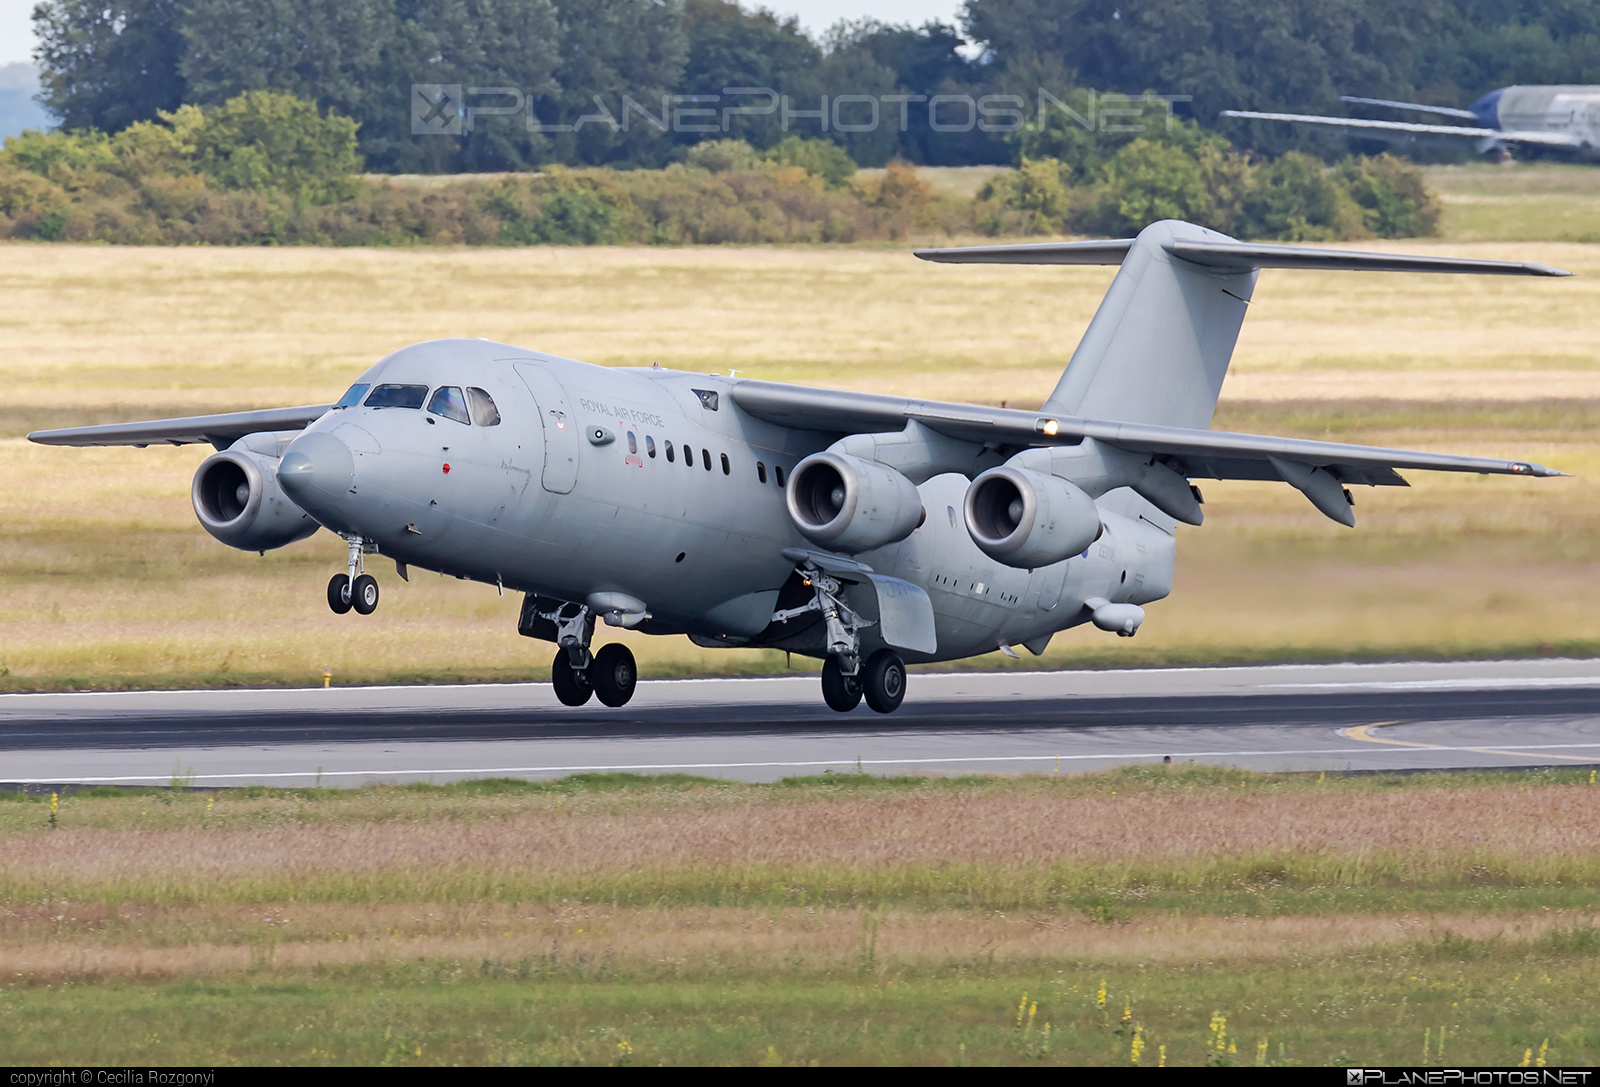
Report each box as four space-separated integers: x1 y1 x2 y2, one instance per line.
0 937 1600 1066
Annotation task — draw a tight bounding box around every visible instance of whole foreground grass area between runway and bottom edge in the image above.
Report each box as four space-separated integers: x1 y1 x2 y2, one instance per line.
0 767 1600 1065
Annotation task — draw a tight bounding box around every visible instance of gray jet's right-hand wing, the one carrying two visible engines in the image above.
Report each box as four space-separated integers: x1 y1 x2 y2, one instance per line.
730 379 1565 487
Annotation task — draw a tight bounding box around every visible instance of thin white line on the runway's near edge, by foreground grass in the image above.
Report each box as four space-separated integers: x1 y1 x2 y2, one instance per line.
5 743 1600 784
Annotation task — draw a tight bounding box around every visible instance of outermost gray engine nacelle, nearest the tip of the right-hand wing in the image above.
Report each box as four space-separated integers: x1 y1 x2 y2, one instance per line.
965 466 1104 570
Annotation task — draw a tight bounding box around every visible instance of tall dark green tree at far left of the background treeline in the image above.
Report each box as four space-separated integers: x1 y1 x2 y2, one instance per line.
34 0 186 133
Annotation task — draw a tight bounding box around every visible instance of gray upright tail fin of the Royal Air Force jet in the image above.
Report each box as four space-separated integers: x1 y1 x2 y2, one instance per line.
1045 219 1256 429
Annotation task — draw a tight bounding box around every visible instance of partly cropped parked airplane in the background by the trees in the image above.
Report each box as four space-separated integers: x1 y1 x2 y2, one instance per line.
1221 85 1600 162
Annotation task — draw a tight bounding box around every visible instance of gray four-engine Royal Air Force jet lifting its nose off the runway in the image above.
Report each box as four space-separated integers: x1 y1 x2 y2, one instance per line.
29 223 1568 712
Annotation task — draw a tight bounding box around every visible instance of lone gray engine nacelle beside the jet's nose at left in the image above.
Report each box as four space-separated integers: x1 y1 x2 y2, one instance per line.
189 443 318 551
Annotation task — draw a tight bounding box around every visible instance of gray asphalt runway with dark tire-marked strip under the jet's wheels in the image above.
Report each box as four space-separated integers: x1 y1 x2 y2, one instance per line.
9 660 1600 786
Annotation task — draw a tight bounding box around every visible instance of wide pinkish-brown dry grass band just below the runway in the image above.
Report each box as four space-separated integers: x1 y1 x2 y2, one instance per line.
9 772 1600 908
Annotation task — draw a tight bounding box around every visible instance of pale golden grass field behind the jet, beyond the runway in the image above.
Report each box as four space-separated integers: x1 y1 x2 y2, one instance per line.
0 235 1600 690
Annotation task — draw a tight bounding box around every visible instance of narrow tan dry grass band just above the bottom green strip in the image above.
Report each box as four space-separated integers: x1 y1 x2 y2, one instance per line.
0 901 1600 985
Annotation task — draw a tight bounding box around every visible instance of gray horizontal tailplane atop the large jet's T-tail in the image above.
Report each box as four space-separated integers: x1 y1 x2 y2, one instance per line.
917 239 1571 275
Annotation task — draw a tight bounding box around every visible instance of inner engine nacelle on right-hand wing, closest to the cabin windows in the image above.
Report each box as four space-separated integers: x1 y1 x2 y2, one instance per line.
784 453 926 554
